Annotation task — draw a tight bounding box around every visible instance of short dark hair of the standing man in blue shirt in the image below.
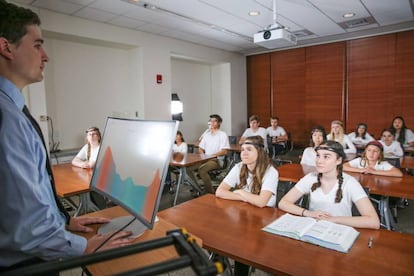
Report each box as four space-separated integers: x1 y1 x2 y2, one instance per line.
0 0 40 43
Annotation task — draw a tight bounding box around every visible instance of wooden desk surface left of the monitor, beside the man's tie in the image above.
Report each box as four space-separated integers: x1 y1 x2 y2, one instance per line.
52 163 93 197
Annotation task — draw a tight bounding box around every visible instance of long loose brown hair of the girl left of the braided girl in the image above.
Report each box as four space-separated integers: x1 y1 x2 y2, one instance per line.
236 135 270 195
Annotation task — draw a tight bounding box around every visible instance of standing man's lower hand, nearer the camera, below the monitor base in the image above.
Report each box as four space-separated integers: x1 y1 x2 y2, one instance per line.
85 231 135 254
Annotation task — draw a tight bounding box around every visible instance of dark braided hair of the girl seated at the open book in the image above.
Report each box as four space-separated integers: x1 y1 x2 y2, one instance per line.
311 140 346 203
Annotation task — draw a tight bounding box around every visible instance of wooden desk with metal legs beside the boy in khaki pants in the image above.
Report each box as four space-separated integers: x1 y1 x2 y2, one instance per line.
170 153 216 206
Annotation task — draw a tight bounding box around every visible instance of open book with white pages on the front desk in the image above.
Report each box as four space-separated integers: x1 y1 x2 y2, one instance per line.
262 214 359 253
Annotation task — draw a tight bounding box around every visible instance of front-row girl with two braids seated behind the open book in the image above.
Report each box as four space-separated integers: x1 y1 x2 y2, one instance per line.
279 141 380 229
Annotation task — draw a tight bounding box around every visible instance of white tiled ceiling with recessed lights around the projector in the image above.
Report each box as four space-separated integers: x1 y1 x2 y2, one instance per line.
14 0 414 54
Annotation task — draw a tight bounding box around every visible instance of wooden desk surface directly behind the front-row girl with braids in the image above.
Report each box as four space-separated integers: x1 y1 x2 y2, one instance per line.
277 164 414 199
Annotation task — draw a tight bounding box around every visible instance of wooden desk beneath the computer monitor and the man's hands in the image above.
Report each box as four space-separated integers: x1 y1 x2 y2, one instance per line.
82 206 202 275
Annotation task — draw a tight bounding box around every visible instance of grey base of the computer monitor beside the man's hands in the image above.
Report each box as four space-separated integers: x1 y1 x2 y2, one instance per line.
98 216 148 238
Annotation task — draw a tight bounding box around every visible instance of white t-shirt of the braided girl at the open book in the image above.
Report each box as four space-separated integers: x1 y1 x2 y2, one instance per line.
295 172 368 216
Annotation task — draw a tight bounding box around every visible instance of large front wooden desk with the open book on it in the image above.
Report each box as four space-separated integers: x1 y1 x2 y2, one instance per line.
159 195 414 275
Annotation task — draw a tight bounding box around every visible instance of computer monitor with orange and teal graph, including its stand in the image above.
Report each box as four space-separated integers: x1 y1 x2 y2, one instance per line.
90 117 178 235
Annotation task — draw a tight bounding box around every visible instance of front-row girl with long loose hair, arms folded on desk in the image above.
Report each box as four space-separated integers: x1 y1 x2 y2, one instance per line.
216 135 279 207
